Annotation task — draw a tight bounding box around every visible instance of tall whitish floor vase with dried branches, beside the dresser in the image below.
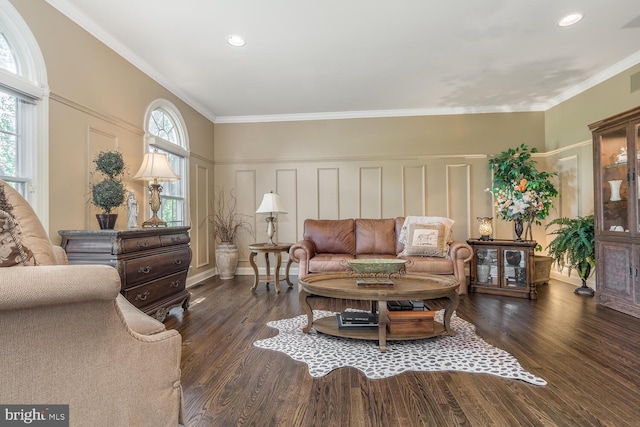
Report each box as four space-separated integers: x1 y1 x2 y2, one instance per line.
209 188 253 279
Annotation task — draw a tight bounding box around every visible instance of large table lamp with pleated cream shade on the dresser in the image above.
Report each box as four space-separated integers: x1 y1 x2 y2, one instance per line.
133 150 180 227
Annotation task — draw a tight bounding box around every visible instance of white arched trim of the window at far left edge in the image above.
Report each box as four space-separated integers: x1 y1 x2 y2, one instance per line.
0 0 49 233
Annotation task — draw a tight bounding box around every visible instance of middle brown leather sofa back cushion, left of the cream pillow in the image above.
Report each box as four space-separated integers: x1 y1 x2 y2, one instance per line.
355 218 396 255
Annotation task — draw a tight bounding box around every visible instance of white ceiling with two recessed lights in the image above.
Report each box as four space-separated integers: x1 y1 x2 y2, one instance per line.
47 0 640 123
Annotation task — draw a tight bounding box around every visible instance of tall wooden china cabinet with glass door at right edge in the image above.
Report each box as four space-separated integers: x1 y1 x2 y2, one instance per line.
589 107 640 317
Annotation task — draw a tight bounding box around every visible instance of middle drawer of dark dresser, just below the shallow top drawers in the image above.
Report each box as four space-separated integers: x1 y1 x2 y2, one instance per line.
123 246 191 288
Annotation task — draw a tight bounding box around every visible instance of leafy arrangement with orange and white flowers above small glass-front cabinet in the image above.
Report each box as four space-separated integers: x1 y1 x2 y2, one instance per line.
486 144 558 229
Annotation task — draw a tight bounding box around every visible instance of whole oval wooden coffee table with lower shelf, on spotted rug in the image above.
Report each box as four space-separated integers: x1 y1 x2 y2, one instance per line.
298 272 460 352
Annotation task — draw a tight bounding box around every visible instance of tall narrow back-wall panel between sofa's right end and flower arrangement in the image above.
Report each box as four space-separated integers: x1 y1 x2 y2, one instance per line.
446 164 471 241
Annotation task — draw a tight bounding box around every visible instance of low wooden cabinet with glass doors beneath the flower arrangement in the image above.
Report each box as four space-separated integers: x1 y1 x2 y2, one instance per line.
467 239 538 299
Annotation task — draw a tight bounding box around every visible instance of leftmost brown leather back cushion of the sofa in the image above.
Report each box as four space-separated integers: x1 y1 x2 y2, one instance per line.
304 219 356 254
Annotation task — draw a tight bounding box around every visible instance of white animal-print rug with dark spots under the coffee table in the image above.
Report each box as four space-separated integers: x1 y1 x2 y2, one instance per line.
253 310 547 385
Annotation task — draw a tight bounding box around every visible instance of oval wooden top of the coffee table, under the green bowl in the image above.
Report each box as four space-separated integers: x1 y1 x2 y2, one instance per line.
298 272 460 301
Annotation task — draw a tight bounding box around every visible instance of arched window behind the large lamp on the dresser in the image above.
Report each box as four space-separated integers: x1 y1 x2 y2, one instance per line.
145 99 189 226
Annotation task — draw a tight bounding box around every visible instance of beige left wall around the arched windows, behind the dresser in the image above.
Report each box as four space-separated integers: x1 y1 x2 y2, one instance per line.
12 0 214 282
